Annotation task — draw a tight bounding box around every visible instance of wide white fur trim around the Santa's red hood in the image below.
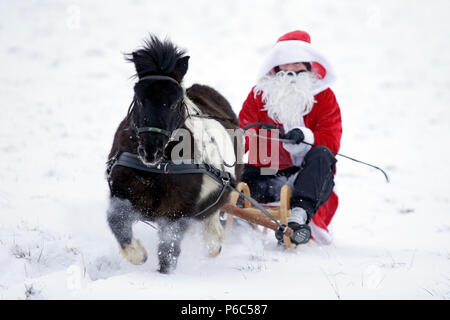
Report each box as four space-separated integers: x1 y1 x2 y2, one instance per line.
257 40 336 95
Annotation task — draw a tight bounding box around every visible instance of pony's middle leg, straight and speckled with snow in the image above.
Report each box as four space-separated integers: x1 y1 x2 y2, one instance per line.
158 218 189 273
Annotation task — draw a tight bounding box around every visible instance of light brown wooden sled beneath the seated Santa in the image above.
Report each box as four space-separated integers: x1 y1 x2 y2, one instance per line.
222 182 292 248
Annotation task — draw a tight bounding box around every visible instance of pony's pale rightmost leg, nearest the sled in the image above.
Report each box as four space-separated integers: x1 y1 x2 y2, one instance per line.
203 210 225 257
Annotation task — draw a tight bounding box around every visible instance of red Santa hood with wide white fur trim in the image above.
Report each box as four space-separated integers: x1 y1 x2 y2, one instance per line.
258 30 336 94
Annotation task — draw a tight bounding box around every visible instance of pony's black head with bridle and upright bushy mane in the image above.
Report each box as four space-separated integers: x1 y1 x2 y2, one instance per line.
127 36 189 164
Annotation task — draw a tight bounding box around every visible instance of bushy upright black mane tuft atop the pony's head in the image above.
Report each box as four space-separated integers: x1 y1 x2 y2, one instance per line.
125 35 186 78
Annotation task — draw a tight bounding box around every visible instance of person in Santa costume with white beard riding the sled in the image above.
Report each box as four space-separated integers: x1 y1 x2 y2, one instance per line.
239 31 342 244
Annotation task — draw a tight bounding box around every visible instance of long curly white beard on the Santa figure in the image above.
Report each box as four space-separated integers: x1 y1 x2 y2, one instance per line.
254 71 318 127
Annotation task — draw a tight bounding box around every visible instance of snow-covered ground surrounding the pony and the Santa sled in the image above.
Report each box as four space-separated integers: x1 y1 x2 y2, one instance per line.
0 0 450 299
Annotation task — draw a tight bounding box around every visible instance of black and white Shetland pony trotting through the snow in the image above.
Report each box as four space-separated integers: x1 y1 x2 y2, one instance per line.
107 36 242 273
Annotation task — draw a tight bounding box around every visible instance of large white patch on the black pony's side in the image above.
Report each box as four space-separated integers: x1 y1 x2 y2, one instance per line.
184 95 235 201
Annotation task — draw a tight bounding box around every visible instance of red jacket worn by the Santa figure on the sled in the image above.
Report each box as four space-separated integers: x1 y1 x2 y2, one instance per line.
239 88 342 236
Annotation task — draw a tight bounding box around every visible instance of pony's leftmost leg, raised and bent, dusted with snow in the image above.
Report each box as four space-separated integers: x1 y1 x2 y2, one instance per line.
107 198 147 264
